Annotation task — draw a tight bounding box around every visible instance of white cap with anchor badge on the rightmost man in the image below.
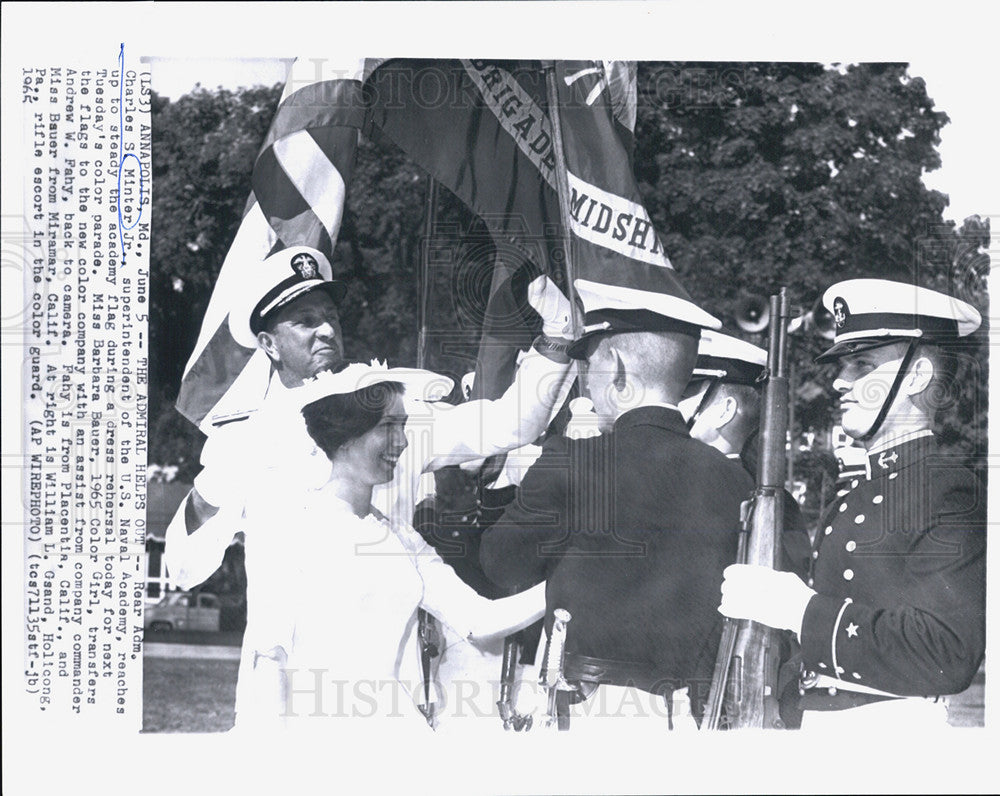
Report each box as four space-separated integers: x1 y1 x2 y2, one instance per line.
816 279 982 362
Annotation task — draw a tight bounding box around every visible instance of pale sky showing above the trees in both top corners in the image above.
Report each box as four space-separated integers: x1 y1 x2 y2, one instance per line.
149 56 1000 223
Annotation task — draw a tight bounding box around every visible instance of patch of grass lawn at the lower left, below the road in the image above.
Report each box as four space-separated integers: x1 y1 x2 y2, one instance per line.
142 657 239 732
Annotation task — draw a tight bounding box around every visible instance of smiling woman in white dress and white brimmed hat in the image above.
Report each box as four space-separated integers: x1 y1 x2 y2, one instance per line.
239 365 545 731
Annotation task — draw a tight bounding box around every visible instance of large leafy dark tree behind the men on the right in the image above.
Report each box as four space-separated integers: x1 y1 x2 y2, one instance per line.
635 63 986 486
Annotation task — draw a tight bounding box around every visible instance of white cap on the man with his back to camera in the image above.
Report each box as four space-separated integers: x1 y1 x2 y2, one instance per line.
568 276 722 359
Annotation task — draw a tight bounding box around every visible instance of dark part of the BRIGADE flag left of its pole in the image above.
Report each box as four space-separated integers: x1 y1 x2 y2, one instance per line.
365 59 565 398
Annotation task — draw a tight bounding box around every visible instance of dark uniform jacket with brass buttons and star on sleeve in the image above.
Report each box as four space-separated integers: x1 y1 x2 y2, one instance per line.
799 431 986 709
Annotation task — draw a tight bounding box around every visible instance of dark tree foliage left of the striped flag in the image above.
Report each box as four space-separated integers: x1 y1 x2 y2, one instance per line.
149 86 288 480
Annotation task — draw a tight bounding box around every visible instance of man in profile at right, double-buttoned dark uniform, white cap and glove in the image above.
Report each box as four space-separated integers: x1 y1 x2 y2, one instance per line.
719 279 986 729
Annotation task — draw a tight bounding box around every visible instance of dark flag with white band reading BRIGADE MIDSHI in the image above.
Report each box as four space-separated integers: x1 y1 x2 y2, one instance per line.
366 60 708 397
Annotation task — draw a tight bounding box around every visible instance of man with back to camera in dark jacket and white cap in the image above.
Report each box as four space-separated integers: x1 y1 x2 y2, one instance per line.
481 280 753 738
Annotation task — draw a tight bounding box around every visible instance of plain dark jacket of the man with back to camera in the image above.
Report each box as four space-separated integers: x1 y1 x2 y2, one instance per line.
481 406 753 715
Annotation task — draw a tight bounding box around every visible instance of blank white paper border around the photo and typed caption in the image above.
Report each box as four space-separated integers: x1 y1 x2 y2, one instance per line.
2 0 1000 794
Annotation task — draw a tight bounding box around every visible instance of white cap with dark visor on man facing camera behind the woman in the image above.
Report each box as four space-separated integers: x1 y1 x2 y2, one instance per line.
229 246 346 348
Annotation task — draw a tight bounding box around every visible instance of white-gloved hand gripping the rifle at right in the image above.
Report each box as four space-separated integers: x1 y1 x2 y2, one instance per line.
719 564 816 633
